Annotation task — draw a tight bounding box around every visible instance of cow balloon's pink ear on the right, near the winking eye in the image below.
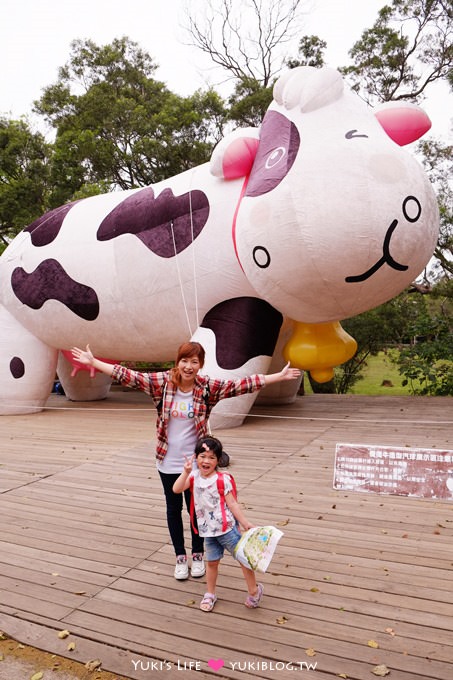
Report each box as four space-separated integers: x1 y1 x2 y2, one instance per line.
374 102 431 146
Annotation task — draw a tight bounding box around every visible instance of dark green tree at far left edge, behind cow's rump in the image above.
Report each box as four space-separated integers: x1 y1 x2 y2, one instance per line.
0 118 51 252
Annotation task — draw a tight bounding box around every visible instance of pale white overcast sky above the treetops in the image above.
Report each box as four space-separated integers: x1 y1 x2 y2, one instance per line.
0 0 451 136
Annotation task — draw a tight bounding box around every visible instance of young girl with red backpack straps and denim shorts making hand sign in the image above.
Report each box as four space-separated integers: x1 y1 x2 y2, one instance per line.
173 437 264 612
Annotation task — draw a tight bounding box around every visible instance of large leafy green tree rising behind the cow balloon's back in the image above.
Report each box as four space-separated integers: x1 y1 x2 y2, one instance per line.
35 37 224 194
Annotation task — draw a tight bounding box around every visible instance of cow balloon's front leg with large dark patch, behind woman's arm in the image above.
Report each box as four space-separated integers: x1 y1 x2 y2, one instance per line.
192 297 283 429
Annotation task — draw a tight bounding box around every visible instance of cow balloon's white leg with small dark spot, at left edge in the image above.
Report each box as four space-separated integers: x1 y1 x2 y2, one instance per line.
0 306 57 415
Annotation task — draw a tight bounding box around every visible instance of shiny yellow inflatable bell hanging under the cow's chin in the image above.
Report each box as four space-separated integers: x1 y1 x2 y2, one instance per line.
283 321 357 383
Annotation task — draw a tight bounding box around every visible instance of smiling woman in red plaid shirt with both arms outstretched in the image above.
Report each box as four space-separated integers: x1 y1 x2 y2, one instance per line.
71 342 300 580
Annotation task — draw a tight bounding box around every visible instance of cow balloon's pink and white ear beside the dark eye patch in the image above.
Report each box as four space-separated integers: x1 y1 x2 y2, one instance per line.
210 128 259 179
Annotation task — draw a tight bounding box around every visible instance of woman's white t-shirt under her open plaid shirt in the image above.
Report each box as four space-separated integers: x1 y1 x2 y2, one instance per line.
157 389 197 474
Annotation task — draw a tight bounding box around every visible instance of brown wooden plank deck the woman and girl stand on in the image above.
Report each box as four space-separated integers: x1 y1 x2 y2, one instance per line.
0 390 453 680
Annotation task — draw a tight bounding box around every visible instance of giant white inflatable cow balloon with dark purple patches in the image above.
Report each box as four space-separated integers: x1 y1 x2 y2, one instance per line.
0 67 438 426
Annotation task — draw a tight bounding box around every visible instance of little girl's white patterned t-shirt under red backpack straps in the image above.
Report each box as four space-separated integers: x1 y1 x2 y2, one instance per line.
192 468 236 537
